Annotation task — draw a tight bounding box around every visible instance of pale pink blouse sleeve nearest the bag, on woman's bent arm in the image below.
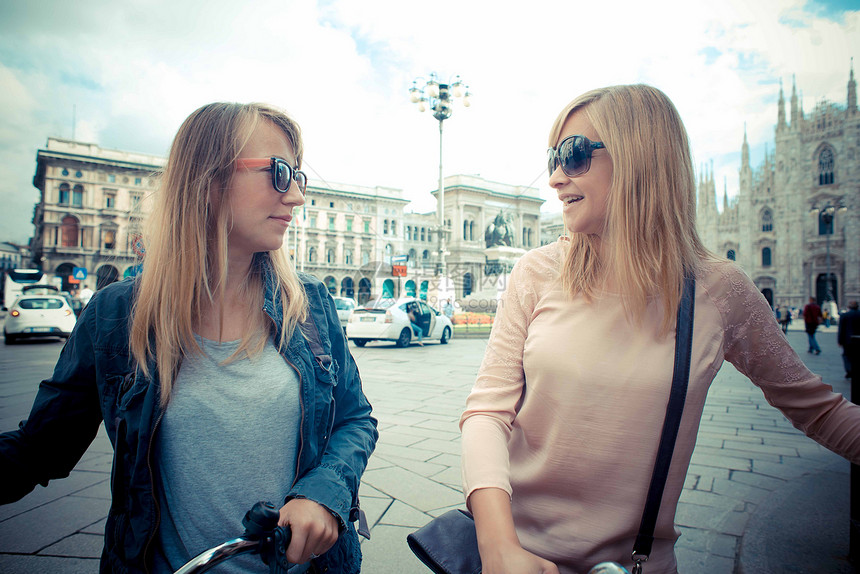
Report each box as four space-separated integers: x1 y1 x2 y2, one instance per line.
460 248 558 500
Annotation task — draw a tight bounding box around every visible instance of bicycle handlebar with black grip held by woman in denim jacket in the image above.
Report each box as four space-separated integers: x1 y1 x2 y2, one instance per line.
174 502 292 574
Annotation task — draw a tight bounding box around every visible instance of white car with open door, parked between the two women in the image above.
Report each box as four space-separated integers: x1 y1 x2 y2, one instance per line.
346 297 454 347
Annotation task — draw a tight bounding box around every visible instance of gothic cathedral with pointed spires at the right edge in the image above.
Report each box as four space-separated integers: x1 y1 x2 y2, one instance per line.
697 63 860 309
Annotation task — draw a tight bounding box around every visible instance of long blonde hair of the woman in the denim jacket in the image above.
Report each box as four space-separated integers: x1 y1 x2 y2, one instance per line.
129 103 307 406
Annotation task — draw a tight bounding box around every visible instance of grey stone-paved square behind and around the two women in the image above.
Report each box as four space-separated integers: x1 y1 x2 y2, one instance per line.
0 328 851 574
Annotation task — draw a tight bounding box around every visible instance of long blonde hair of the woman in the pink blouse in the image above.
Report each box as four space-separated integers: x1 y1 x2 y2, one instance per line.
549 84 712 335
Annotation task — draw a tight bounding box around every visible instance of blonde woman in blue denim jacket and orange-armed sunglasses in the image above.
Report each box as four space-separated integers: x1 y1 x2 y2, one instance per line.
0 103 377 573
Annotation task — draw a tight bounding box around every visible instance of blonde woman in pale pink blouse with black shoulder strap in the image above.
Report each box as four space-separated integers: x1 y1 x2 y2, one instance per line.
461 85 860 574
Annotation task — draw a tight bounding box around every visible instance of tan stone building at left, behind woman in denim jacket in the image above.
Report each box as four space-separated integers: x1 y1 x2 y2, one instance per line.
30 138 165 291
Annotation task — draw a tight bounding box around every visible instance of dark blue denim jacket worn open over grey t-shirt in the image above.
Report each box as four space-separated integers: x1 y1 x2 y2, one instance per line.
0 265 378 573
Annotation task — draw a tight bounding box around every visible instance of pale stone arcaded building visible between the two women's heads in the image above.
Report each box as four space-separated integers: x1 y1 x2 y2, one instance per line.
287 175 543 305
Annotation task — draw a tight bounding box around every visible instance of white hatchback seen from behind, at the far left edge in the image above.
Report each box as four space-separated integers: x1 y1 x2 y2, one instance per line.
3 294 77 345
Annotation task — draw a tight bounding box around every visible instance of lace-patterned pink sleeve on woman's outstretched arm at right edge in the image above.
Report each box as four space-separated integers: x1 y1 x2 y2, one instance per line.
703 263 860 463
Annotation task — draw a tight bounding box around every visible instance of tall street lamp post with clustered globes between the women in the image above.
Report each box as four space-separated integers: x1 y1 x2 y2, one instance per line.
409 74 471 281
